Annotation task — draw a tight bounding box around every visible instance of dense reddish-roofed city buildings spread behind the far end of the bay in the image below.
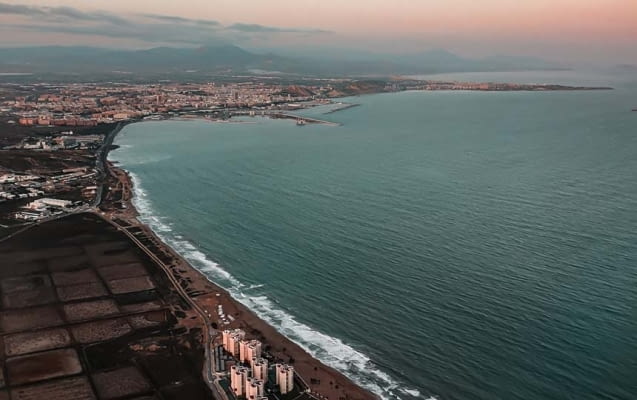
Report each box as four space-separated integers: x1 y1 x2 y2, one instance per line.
0 82 322 128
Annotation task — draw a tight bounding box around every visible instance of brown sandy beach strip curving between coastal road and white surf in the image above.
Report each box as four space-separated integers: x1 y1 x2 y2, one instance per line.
104 123 380 400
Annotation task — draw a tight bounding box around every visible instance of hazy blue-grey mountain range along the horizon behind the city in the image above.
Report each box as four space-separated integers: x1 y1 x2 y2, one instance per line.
0 45 555 76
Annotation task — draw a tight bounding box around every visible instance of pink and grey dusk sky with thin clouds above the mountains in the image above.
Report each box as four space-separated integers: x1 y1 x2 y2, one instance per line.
0 0 637 64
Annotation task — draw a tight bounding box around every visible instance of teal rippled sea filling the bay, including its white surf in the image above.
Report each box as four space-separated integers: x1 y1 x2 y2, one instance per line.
109 71 637 400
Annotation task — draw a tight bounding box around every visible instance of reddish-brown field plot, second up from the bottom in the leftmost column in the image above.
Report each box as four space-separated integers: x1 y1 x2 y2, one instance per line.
7 349 82 386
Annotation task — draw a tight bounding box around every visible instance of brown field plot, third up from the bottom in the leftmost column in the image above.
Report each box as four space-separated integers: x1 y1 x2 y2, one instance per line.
4 328 71 357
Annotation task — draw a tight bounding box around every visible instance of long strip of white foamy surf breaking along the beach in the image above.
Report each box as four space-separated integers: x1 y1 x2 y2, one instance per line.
129 171 424 400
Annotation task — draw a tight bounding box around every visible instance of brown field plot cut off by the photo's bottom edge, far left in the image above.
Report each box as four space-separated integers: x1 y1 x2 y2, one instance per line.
11 376 96 400
